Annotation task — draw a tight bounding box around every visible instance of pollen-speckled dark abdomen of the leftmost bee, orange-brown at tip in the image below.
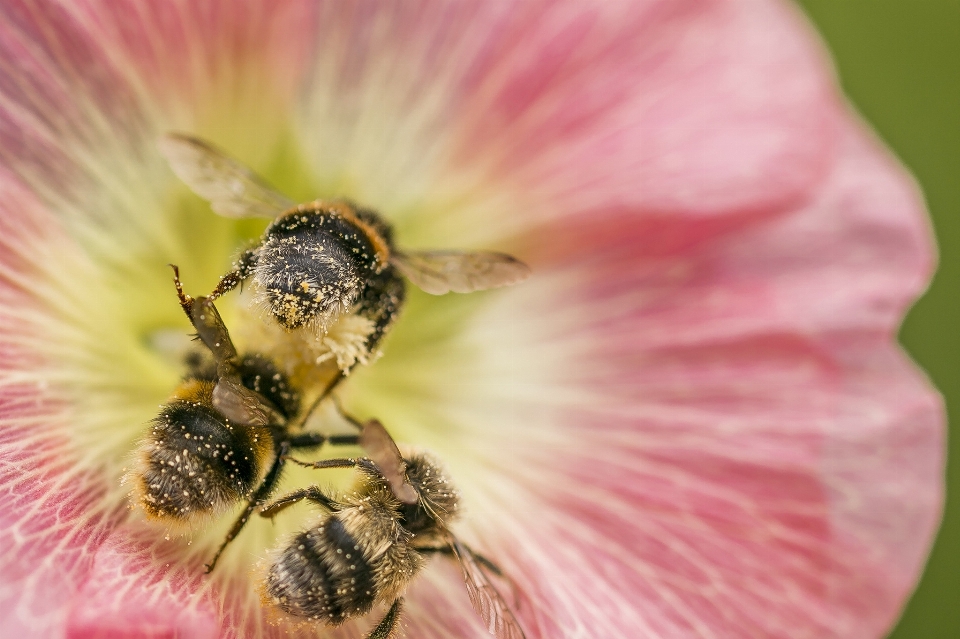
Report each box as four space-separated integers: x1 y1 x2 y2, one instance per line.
140 400 272 519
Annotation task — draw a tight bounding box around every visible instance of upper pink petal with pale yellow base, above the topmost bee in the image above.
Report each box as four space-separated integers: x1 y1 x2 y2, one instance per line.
268 0 835 245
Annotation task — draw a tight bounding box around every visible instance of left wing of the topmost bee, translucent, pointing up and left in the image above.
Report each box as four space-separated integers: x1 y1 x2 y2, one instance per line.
158 133 296 218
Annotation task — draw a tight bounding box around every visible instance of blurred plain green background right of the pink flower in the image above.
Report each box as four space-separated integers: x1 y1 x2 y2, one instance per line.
799 0 960 639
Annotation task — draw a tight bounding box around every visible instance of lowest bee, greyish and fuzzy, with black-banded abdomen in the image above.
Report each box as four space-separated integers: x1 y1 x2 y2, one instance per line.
260 420 525 639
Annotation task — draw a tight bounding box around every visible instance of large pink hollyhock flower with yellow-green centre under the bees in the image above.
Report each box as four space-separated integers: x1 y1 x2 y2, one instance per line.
0 0 944 639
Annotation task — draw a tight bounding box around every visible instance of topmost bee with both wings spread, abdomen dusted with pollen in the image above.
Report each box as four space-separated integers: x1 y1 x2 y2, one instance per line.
160 134 530 347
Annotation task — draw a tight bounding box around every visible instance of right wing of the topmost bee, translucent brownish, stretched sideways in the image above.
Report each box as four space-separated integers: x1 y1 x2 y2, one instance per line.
391 251 530 295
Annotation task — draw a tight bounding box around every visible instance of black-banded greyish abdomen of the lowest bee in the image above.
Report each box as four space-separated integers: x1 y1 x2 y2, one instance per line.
266 516 378 625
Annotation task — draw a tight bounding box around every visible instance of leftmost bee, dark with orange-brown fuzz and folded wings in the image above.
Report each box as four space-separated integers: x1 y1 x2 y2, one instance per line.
136 266 359 572
